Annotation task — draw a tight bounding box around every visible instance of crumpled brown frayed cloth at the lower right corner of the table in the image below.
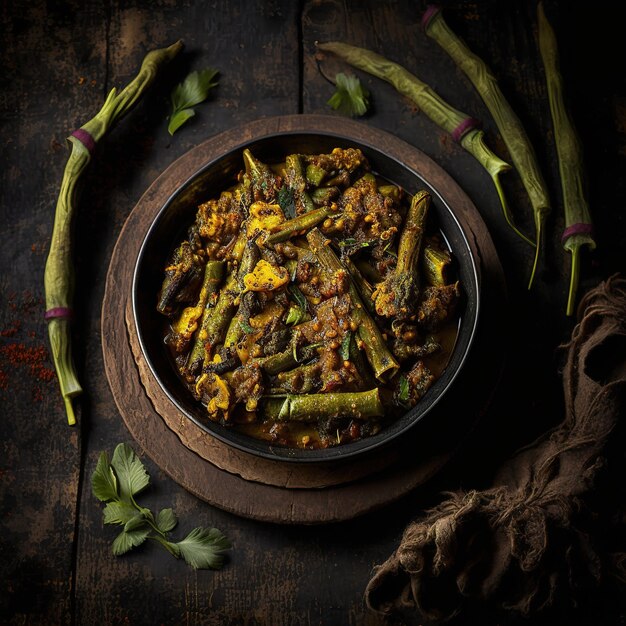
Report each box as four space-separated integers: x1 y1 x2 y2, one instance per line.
365 276 626 620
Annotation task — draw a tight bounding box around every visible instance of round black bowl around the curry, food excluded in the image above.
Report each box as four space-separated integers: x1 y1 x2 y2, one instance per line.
132 116 479 463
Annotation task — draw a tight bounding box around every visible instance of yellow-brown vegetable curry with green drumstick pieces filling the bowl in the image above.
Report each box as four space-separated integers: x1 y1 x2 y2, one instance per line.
155 147 462 449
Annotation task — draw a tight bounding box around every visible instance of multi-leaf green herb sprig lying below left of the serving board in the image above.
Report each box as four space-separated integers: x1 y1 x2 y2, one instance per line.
91 443 231 569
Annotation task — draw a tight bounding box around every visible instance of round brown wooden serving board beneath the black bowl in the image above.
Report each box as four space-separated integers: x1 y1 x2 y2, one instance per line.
102 115 505 524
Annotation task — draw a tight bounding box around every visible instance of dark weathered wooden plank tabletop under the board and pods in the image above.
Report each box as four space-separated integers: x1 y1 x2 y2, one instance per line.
0 0 626 626
